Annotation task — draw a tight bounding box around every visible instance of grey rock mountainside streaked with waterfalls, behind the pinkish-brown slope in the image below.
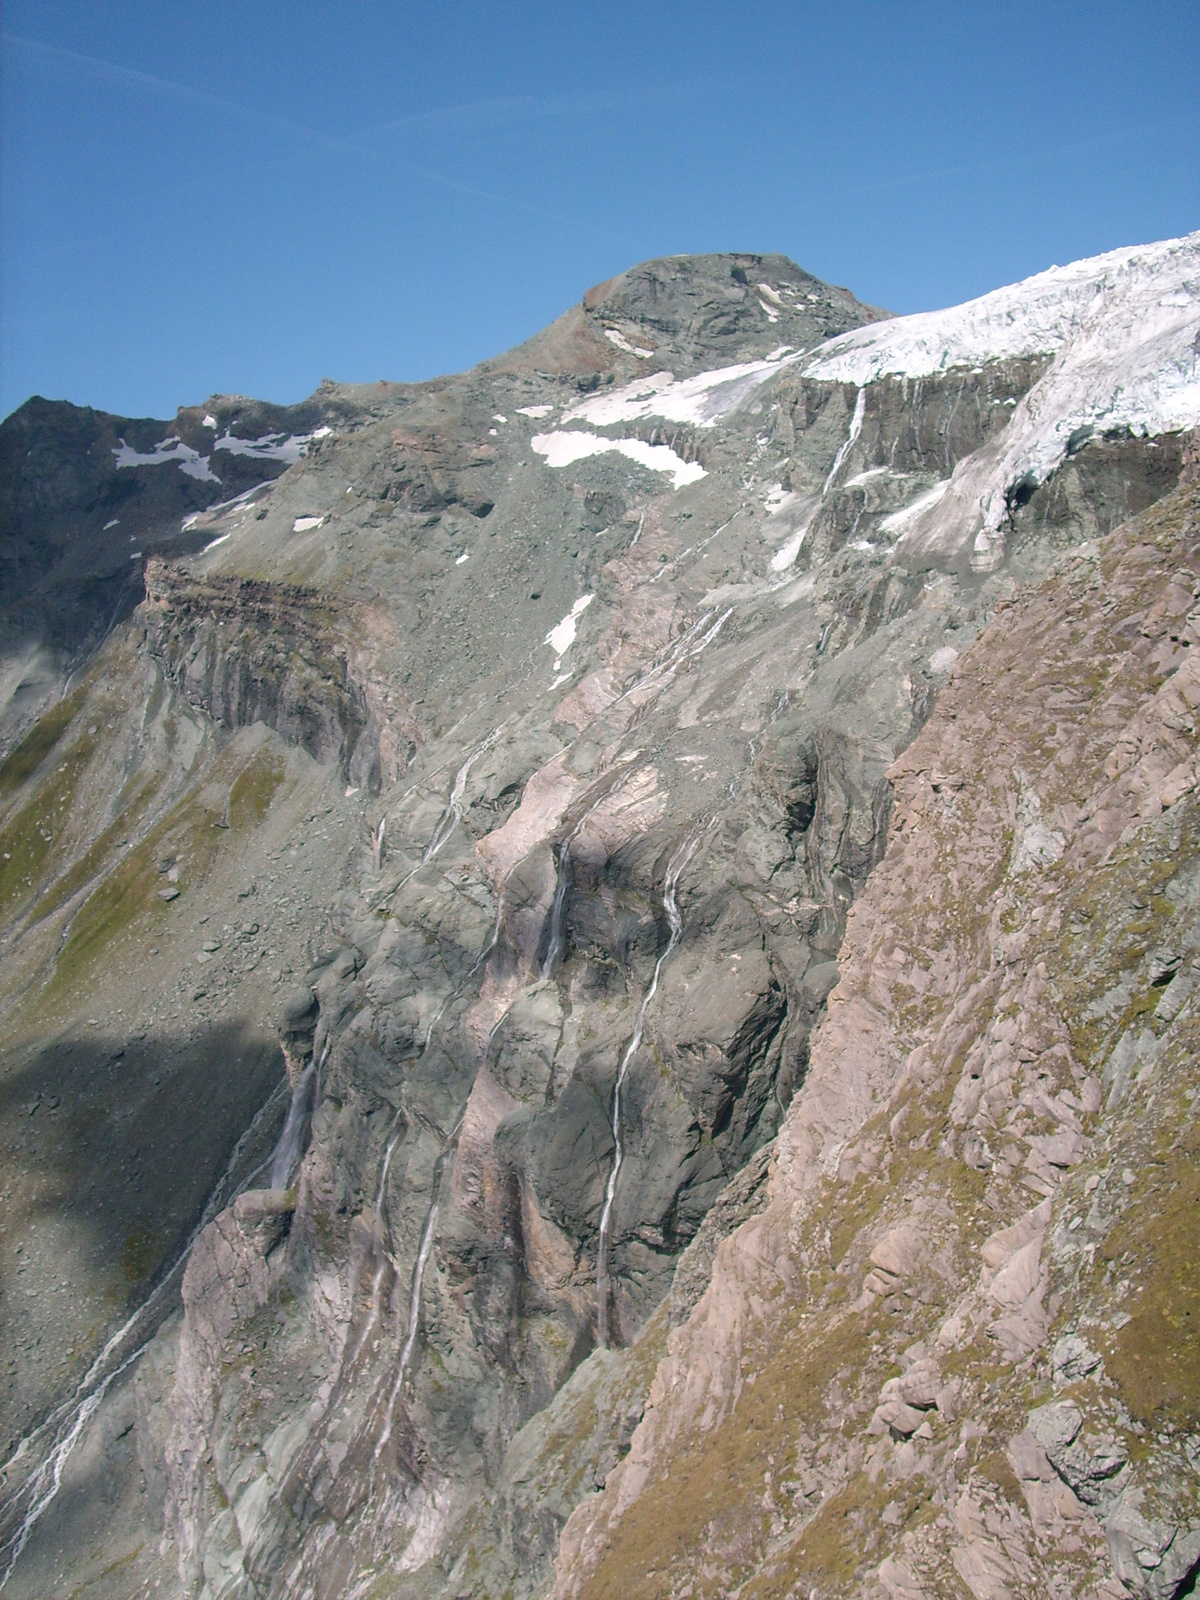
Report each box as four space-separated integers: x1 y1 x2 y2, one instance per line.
0 240 1182 1600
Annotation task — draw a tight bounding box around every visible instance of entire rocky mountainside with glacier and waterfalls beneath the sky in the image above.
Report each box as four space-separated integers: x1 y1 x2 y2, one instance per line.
0 234 1200 1600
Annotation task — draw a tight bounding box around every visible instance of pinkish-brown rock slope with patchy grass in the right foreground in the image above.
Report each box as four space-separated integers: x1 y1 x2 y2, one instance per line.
554 486 1200 1600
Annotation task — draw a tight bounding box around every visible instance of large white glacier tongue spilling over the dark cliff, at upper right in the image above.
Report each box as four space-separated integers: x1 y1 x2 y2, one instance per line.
803 232 1200 570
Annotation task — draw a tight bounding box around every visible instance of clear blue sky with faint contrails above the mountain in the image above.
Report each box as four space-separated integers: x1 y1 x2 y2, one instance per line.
0 0 1200 418
